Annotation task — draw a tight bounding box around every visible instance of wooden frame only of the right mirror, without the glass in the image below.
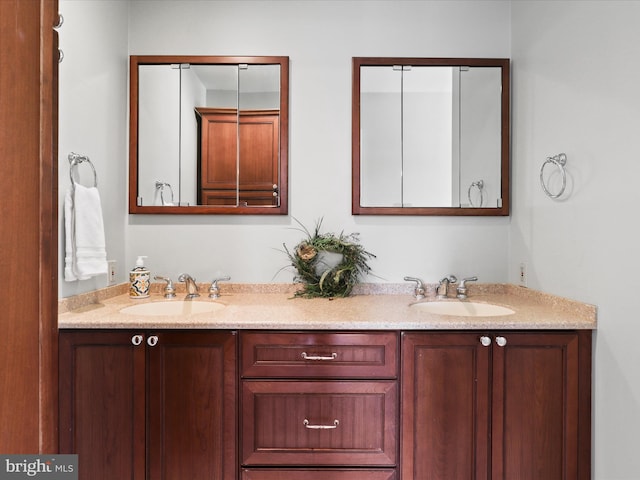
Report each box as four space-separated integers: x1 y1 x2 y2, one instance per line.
351 57 511 216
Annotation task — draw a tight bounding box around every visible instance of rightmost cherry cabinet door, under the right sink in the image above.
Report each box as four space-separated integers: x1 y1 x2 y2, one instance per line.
492 332 591 480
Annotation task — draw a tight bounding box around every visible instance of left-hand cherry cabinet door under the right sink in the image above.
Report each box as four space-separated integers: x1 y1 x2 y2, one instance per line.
400 333 490 480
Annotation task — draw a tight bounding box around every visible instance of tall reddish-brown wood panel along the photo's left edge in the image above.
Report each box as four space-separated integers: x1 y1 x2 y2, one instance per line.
0 0 59 454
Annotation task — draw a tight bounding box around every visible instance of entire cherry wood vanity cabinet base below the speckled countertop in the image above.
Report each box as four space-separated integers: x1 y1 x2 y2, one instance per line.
60 330 591 480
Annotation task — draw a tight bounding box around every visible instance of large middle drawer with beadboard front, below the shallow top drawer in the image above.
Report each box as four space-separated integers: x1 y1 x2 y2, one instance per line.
242 380 398 466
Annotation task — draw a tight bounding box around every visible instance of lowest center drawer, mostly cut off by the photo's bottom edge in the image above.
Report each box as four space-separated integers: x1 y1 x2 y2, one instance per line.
241 468 397 480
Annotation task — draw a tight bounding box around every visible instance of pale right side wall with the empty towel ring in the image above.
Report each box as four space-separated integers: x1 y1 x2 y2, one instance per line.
509 0 640 480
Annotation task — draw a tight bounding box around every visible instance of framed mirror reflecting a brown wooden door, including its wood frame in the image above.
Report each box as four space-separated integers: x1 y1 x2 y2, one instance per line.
129 55 289 215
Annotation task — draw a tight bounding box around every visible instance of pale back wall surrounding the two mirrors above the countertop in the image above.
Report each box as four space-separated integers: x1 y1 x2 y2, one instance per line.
126 0 510 282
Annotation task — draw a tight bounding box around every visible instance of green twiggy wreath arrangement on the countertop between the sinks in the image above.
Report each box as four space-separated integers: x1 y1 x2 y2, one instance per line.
283 219 375 298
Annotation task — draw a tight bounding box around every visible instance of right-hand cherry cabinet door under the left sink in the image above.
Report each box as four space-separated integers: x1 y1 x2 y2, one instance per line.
147 331 238 480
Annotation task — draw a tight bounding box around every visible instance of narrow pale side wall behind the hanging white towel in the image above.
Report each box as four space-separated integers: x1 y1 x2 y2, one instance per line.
58 0 129 297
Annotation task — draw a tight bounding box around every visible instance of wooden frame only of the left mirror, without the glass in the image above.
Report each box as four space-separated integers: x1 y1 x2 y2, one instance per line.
129 55 289 215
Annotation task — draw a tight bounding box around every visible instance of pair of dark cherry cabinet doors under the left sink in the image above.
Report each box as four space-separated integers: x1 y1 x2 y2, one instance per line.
60 330 237 480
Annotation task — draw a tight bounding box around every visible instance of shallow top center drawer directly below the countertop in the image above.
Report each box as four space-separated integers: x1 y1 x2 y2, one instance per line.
241 332 398 378
